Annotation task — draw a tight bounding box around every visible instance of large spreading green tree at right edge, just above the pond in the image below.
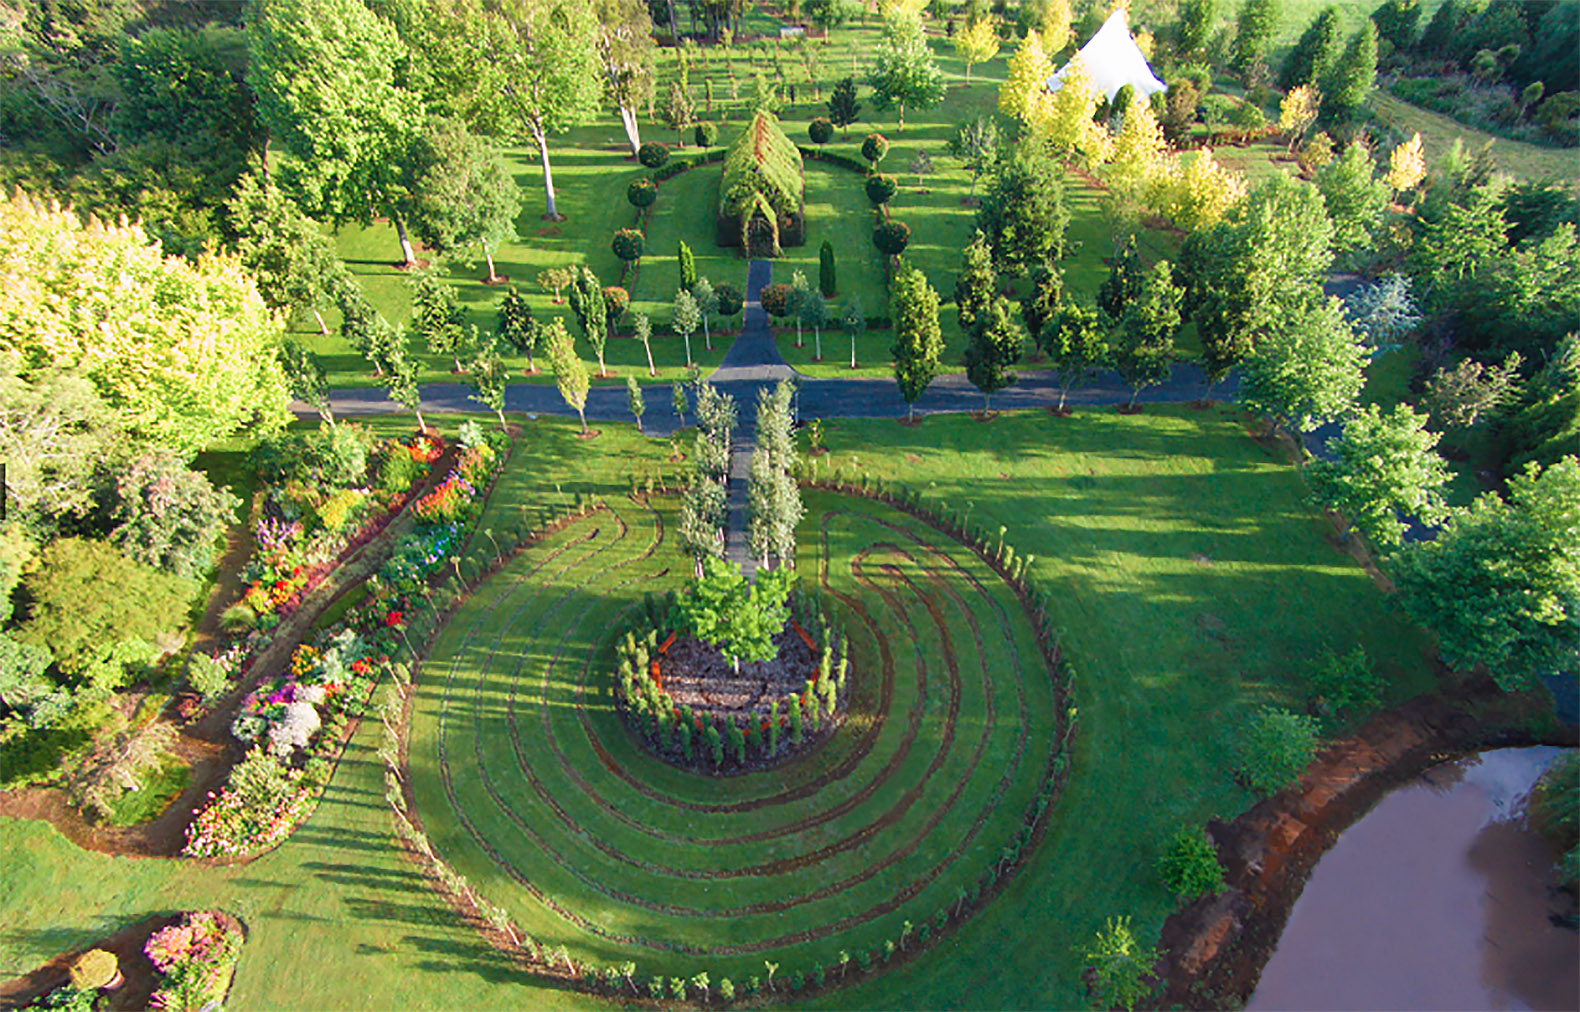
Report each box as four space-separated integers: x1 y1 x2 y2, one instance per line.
1394 456 1580 692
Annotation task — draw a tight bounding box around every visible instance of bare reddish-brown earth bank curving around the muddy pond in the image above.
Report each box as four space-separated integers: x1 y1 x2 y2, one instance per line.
1157 677 1580 1009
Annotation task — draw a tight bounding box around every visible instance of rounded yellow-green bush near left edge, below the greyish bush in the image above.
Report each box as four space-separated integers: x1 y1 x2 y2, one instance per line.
17 538 193 687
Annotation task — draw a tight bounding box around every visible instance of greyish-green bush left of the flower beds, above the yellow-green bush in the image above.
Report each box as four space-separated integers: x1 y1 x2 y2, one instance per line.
111 453 240 578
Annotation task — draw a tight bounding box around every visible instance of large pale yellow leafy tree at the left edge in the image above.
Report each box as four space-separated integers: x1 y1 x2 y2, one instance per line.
0 194 291 453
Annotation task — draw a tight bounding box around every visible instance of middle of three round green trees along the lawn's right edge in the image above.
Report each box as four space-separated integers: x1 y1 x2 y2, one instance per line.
1307 404 1449 548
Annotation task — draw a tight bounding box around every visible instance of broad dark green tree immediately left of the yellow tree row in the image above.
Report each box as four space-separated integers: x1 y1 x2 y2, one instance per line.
976 144 1070 276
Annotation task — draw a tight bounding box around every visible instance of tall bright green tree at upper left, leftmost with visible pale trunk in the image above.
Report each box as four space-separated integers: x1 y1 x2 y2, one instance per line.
246 0 422 264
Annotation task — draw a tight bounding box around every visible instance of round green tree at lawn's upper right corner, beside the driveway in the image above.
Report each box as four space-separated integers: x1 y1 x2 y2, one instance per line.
1240 298 1370 433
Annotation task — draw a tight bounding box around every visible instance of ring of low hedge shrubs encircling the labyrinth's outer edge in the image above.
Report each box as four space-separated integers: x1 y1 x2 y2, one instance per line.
381 479 1076 1007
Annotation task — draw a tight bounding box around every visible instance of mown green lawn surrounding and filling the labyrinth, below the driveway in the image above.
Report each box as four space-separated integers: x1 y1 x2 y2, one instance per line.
0 397 1431 1007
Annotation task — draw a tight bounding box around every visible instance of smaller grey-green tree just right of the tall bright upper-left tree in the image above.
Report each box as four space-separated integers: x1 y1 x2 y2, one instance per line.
411 120 521 284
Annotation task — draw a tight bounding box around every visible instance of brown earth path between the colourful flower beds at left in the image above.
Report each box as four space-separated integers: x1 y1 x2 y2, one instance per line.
0 444 455 864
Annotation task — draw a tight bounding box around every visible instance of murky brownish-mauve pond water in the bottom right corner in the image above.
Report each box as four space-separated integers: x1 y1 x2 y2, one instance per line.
1247 748 1580 1010
